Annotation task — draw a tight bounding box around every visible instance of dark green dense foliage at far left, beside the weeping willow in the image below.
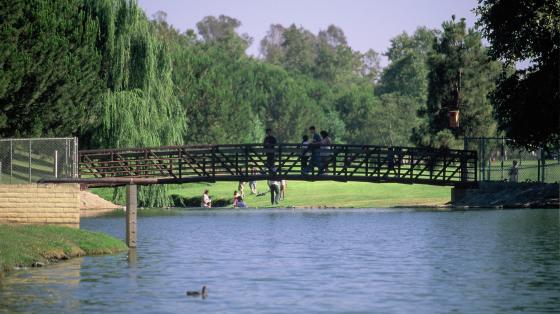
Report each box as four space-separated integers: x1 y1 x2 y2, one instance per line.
0 0 101 137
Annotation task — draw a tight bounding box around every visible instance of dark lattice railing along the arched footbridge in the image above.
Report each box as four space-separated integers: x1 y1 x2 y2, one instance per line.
79 144 477 185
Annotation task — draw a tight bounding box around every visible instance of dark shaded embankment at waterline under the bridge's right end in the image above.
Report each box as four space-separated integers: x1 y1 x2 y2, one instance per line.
451 182 560 208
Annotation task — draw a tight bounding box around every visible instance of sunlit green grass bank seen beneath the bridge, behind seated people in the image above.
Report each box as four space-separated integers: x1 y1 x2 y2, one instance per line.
92 181 451 208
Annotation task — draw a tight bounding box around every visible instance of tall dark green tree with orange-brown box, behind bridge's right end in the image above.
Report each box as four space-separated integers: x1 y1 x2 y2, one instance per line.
414 16 500 146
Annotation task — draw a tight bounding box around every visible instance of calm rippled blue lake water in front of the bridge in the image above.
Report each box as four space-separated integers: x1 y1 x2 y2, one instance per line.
0 209 560 313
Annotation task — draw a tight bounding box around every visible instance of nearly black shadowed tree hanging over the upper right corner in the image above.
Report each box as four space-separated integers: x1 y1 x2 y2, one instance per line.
476 0 560 148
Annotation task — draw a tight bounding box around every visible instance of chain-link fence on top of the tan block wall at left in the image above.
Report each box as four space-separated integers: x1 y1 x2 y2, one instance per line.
0 137 78 184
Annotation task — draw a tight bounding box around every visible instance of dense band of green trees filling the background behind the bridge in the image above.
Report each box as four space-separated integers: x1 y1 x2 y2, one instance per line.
5 0 544 201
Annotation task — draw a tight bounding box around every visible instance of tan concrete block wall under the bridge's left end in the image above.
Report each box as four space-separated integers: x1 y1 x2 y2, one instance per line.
0 183 80 228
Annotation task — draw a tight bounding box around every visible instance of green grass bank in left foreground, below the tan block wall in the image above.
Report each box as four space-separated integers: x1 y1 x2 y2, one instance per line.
0 224 127 276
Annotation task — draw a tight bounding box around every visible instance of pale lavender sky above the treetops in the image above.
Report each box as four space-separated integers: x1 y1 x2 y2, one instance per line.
138 0 477 66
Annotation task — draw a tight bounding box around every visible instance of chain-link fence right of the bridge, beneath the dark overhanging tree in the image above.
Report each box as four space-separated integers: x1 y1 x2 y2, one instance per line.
464 137 560 183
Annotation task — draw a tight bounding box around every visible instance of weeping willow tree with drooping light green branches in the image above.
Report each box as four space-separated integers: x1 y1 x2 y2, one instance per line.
86 0 186 207
